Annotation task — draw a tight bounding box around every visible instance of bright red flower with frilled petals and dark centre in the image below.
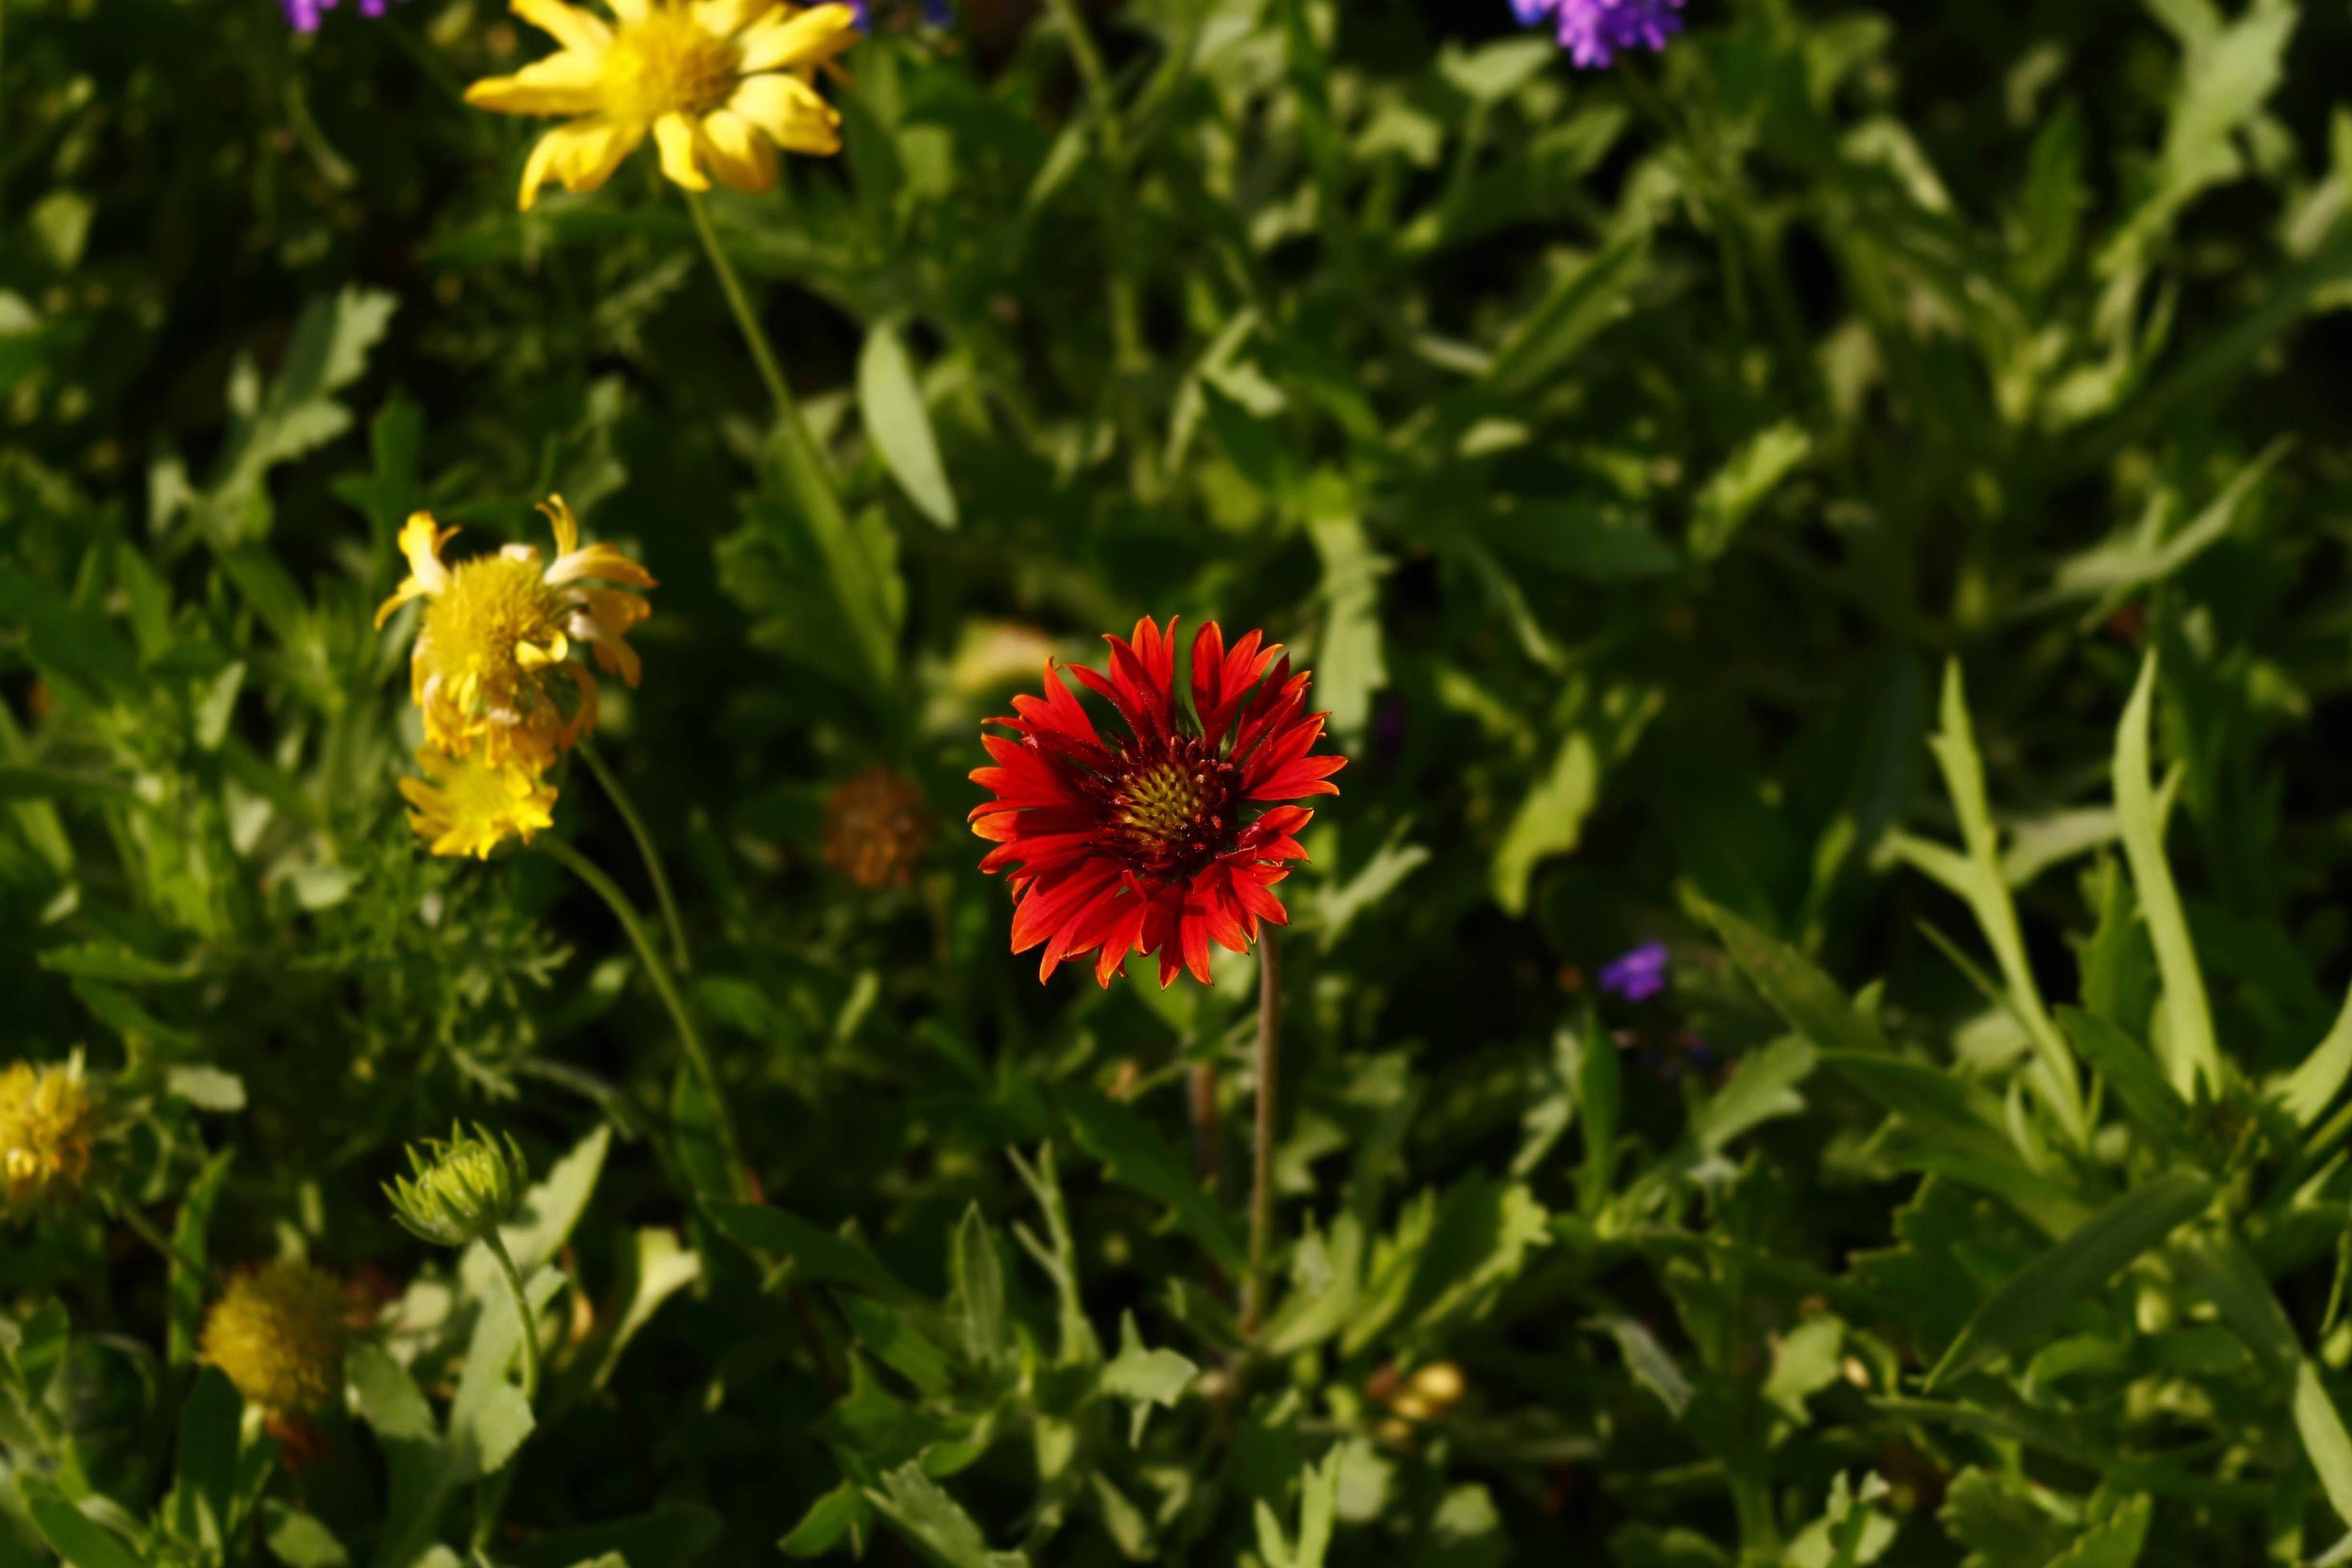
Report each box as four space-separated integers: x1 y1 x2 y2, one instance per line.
971 616 1348 987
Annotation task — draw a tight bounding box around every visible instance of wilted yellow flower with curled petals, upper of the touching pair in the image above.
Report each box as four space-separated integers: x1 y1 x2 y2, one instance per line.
376 496 654 778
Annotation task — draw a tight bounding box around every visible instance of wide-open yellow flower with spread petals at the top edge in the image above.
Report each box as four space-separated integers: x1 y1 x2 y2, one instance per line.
466 0 856 210
